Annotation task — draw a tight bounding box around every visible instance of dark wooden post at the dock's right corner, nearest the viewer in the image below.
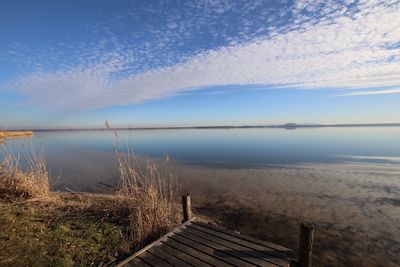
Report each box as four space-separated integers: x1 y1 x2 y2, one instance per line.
299 222 314 267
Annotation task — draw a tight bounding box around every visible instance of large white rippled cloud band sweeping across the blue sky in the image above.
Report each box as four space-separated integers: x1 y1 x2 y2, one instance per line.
3 1 400 108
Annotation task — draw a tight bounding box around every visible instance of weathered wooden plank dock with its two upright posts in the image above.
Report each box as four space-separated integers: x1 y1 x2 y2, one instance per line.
117 196 313 267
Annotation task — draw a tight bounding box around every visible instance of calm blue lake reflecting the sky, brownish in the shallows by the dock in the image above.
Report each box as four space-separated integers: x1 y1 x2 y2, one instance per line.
0 127 400 266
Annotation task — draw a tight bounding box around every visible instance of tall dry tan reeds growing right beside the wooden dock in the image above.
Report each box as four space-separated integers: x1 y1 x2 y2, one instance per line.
111 125 179 249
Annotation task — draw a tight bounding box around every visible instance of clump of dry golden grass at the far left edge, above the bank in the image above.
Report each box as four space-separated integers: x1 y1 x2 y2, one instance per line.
0 147 50 198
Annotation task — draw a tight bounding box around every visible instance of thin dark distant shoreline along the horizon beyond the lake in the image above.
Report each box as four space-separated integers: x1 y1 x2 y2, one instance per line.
8 123 400 132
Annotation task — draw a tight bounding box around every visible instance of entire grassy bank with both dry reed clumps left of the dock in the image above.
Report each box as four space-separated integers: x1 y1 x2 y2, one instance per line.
0 135 180 266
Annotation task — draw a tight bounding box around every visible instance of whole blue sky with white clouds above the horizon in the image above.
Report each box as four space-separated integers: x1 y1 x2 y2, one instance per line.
0 0 400 129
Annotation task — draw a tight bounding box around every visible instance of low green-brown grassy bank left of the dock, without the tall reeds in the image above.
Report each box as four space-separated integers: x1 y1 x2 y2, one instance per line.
0 193 134 266
